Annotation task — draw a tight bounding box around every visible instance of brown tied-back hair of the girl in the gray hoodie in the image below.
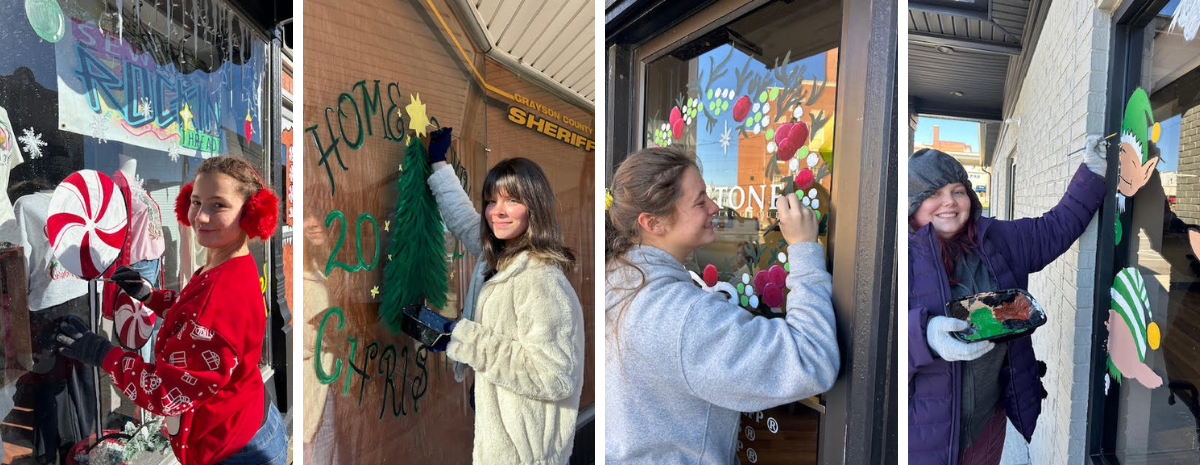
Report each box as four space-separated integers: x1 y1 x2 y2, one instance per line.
604 147 700 351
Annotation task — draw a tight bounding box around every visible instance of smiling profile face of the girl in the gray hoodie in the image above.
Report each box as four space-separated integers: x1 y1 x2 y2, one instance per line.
662 168 720 255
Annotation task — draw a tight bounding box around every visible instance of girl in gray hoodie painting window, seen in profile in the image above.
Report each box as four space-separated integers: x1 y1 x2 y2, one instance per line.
605 147 839 464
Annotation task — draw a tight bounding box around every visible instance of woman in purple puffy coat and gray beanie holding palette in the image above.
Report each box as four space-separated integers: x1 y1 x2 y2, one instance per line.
908 137 1106 465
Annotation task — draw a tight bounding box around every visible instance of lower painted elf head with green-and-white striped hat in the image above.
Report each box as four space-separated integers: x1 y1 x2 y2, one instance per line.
1105 267 1163 388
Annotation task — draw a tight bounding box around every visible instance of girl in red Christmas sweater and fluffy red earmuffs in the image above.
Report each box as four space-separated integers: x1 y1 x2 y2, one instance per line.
58 157 288 465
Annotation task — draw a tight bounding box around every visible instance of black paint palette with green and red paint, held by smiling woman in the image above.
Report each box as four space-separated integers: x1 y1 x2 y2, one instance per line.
946 289 1046 343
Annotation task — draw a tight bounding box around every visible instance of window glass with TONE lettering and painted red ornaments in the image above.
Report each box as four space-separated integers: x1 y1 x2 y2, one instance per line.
642 1 841 464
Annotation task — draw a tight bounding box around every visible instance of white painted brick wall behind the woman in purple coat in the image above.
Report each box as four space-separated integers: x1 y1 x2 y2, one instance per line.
992 0 1111 464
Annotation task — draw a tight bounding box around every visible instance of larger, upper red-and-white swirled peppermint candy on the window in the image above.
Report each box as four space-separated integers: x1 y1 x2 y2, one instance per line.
46 169 130 279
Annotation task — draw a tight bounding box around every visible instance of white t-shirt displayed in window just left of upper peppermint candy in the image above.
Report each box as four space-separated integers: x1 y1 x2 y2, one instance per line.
14 192 88 312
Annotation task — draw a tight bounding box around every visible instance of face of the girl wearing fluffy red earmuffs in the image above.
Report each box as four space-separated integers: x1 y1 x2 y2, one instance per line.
187 173 247 249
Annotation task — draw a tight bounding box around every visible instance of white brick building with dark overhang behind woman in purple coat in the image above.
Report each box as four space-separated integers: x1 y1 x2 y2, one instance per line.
908 0 1200 464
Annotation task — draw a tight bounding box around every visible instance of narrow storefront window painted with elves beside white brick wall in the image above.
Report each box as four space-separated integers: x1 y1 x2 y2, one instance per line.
1104 4 1200 463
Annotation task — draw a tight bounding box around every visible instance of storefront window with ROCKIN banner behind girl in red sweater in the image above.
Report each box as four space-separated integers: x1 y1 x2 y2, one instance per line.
0 0 277 463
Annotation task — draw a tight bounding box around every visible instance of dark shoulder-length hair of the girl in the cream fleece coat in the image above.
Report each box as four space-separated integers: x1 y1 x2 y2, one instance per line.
479 158 575 277
